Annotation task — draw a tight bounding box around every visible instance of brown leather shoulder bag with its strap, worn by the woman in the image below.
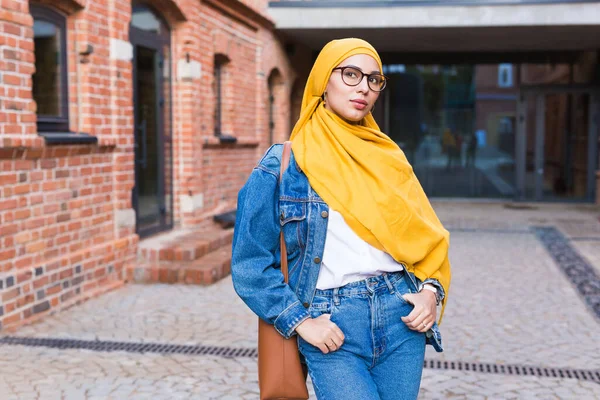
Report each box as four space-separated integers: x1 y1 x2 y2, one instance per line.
258 142 308 400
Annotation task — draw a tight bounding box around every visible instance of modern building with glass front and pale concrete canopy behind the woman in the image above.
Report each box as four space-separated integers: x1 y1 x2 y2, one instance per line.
269 0 600 202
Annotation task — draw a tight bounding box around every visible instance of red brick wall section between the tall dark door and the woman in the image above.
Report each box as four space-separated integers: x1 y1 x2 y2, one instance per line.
175 1 304 225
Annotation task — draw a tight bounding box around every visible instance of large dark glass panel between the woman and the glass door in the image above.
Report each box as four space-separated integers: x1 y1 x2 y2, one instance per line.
384 64 516 197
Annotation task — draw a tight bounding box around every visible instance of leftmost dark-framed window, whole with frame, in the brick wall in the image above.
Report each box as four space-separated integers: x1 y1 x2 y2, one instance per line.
31 5 69 132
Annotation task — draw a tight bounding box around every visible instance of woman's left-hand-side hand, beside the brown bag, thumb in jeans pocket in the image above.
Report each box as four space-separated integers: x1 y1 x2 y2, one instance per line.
296 314 344 354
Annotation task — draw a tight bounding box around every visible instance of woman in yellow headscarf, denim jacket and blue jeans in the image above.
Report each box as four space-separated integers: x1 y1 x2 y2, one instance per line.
232 39 450 400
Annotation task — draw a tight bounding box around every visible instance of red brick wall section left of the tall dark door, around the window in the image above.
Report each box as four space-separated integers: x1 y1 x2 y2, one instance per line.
0 0 137 327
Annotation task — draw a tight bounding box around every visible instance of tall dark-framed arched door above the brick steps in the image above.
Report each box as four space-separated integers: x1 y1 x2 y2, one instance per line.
129 5 173 237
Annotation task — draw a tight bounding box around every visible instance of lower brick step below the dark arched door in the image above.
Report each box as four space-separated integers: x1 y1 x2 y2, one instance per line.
127 244 231 285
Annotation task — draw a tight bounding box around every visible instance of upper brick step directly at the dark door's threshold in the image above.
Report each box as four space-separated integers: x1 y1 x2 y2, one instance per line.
138 227 233 263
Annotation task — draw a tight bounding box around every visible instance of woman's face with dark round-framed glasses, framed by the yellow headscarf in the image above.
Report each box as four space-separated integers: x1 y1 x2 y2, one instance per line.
325 54 380 123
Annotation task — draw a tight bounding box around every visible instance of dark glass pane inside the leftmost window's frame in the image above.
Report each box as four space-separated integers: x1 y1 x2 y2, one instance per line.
32 19 64 117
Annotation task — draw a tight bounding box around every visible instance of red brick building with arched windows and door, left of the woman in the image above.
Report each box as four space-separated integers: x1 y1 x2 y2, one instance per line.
0 0 314 328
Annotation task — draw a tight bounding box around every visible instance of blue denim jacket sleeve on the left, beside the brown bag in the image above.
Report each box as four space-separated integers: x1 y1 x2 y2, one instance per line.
231 165 309 338
